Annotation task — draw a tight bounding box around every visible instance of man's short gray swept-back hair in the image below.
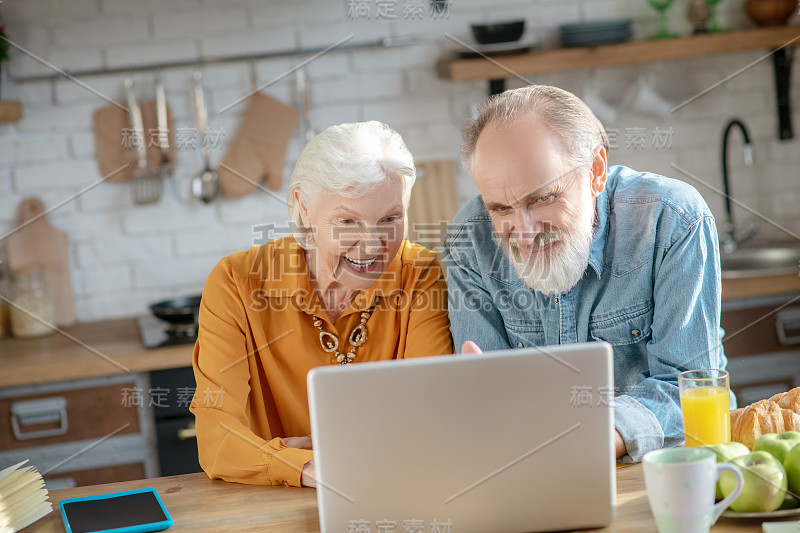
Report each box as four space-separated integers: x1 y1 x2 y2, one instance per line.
461 85 608 174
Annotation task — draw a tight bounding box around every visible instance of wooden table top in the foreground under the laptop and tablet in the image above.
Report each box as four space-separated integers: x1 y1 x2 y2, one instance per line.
23 464 792 533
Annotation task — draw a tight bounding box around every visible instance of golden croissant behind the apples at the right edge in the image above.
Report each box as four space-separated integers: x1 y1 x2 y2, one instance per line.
731 387 800 450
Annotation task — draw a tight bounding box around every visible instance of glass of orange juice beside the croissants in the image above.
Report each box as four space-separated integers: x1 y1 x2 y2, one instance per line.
678 369 731 447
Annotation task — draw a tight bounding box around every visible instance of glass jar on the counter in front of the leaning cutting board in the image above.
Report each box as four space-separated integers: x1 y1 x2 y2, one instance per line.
11 268 55 338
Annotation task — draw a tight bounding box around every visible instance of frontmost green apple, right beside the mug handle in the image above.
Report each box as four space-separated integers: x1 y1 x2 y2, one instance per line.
719 451 788 512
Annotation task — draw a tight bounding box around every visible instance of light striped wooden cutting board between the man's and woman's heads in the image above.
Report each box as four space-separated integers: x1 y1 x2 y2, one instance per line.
408 159 458 251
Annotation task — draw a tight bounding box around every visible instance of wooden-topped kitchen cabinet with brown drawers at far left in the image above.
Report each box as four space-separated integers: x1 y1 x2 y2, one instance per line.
0 319 196 488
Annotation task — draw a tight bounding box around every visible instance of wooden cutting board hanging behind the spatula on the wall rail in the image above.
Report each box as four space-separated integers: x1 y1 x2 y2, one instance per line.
92 101 177 182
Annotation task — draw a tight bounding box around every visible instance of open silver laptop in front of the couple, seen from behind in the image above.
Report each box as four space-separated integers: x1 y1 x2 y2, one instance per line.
308 342 616 533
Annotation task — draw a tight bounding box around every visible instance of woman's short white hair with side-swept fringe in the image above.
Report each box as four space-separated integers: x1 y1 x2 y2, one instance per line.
287 120 417 248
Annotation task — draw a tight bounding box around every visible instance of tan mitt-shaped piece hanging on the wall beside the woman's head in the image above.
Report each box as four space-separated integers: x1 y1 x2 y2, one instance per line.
217 92 300 198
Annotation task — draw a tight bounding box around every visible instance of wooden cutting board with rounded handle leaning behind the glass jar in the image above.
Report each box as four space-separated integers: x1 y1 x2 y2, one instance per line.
6 198 75 327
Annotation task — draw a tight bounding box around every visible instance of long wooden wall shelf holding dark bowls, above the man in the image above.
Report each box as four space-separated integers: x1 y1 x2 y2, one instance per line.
437 26 800 81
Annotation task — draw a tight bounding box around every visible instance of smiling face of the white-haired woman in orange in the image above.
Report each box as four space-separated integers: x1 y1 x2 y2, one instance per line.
299 178 406 290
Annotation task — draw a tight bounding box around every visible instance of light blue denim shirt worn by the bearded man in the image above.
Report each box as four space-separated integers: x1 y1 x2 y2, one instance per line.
443 166 735 462
